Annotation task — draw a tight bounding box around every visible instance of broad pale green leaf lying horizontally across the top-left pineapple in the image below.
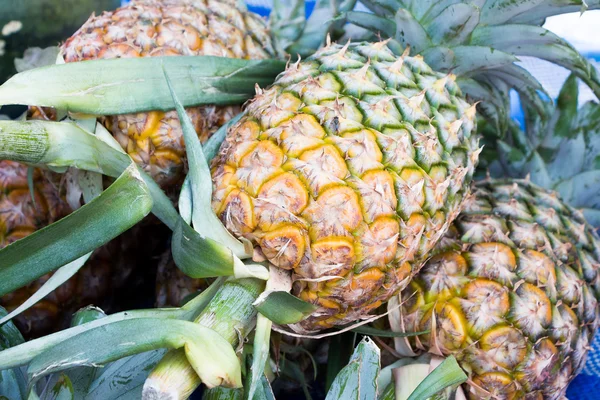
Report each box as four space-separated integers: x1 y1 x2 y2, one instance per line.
0 56 285 115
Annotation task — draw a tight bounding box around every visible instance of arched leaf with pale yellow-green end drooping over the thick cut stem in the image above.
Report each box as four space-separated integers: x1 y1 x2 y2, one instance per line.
27 318 241 387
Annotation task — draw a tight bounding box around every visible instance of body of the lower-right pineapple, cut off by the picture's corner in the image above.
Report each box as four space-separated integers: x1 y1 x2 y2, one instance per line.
399 180 600 399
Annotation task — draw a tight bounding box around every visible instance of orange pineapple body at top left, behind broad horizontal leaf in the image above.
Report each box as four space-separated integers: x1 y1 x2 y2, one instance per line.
61 0 276 189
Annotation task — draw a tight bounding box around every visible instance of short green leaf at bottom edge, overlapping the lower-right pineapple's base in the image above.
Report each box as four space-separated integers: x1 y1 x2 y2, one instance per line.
408 356 467 400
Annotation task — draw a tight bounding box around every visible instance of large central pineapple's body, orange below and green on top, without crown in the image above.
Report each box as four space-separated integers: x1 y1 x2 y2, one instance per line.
212 42 479 331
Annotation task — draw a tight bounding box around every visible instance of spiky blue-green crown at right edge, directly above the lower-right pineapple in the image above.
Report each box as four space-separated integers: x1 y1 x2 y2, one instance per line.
481 74 600 227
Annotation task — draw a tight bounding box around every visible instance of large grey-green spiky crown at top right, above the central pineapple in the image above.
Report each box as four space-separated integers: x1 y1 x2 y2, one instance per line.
340 0 600 132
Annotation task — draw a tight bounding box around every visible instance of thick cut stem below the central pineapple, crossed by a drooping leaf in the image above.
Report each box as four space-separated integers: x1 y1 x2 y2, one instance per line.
142 278 265 399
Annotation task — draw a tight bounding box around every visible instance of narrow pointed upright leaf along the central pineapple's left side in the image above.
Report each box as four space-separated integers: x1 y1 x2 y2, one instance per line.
163 68 251 258
